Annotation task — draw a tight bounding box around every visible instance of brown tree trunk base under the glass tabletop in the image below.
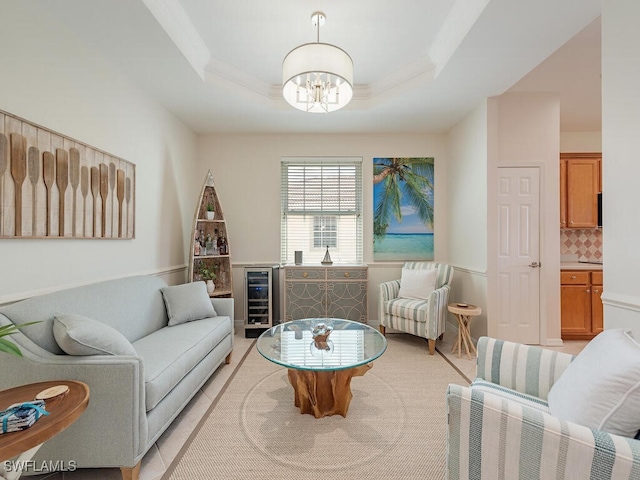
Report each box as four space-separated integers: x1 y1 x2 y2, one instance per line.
288 363 373 418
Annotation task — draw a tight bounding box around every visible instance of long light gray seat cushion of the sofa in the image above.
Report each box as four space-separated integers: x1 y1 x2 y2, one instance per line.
133 316 233 411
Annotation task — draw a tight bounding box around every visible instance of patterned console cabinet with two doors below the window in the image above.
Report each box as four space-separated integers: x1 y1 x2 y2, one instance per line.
284 265 368 323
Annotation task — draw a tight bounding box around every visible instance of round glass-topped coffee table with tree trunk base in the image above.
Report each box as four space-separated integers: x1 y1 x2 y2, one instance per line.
257 318 387 418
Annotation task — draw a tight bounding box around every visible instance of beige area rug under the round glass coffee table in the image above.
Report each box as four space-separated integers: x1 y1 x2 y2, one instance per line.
165 334 468 480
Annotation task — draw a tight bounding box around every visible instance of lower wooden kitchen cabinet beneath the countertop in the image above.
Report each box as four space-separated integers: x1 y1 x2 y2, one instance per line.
560 270 603 340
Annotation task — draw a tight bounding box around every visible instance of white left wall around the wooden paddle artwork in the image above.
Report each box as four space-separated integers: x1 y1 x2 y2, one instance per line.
0 2 196 303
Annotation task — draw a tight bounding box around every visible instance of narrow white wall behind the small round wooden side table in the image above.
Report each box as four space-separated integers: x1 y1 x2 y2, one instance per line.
446 101 487 338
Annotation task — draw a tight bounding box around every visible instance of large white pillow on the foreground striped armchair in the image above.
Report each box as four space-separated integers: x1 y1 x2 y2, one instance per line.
548 329 640 437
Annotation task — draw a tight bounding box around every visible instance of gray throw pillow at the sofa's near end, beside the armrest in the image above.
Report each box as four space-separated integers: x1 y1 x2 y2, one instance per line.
53 314 137 355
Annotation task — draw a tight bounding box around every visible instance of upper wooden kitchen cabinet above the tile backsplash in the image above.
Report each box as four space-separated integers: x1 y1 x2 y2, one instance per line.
560 153 602 228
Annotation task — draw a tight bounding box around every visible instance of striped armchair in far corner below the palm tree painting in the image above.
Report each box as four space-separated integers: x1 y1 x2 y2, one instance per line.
378 262 453 355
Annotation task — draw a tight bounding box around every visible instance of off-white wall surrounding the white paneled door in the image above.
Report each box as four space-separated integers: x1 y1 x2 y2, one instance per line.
487 93 562 345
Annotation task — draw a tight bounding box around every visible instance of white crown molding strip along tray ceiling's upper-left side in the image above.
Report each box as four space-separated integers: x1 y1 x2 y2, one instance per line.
142 0 211 80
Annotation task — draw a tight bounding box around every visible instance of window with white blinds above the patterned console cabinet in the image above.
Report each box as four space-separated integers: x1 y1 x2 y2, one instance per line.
280 157 363 263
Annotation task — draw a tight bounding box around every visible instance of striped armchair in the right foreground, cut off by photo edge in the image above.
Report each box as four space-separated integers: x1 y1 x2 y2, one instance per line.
447 337 640 480
